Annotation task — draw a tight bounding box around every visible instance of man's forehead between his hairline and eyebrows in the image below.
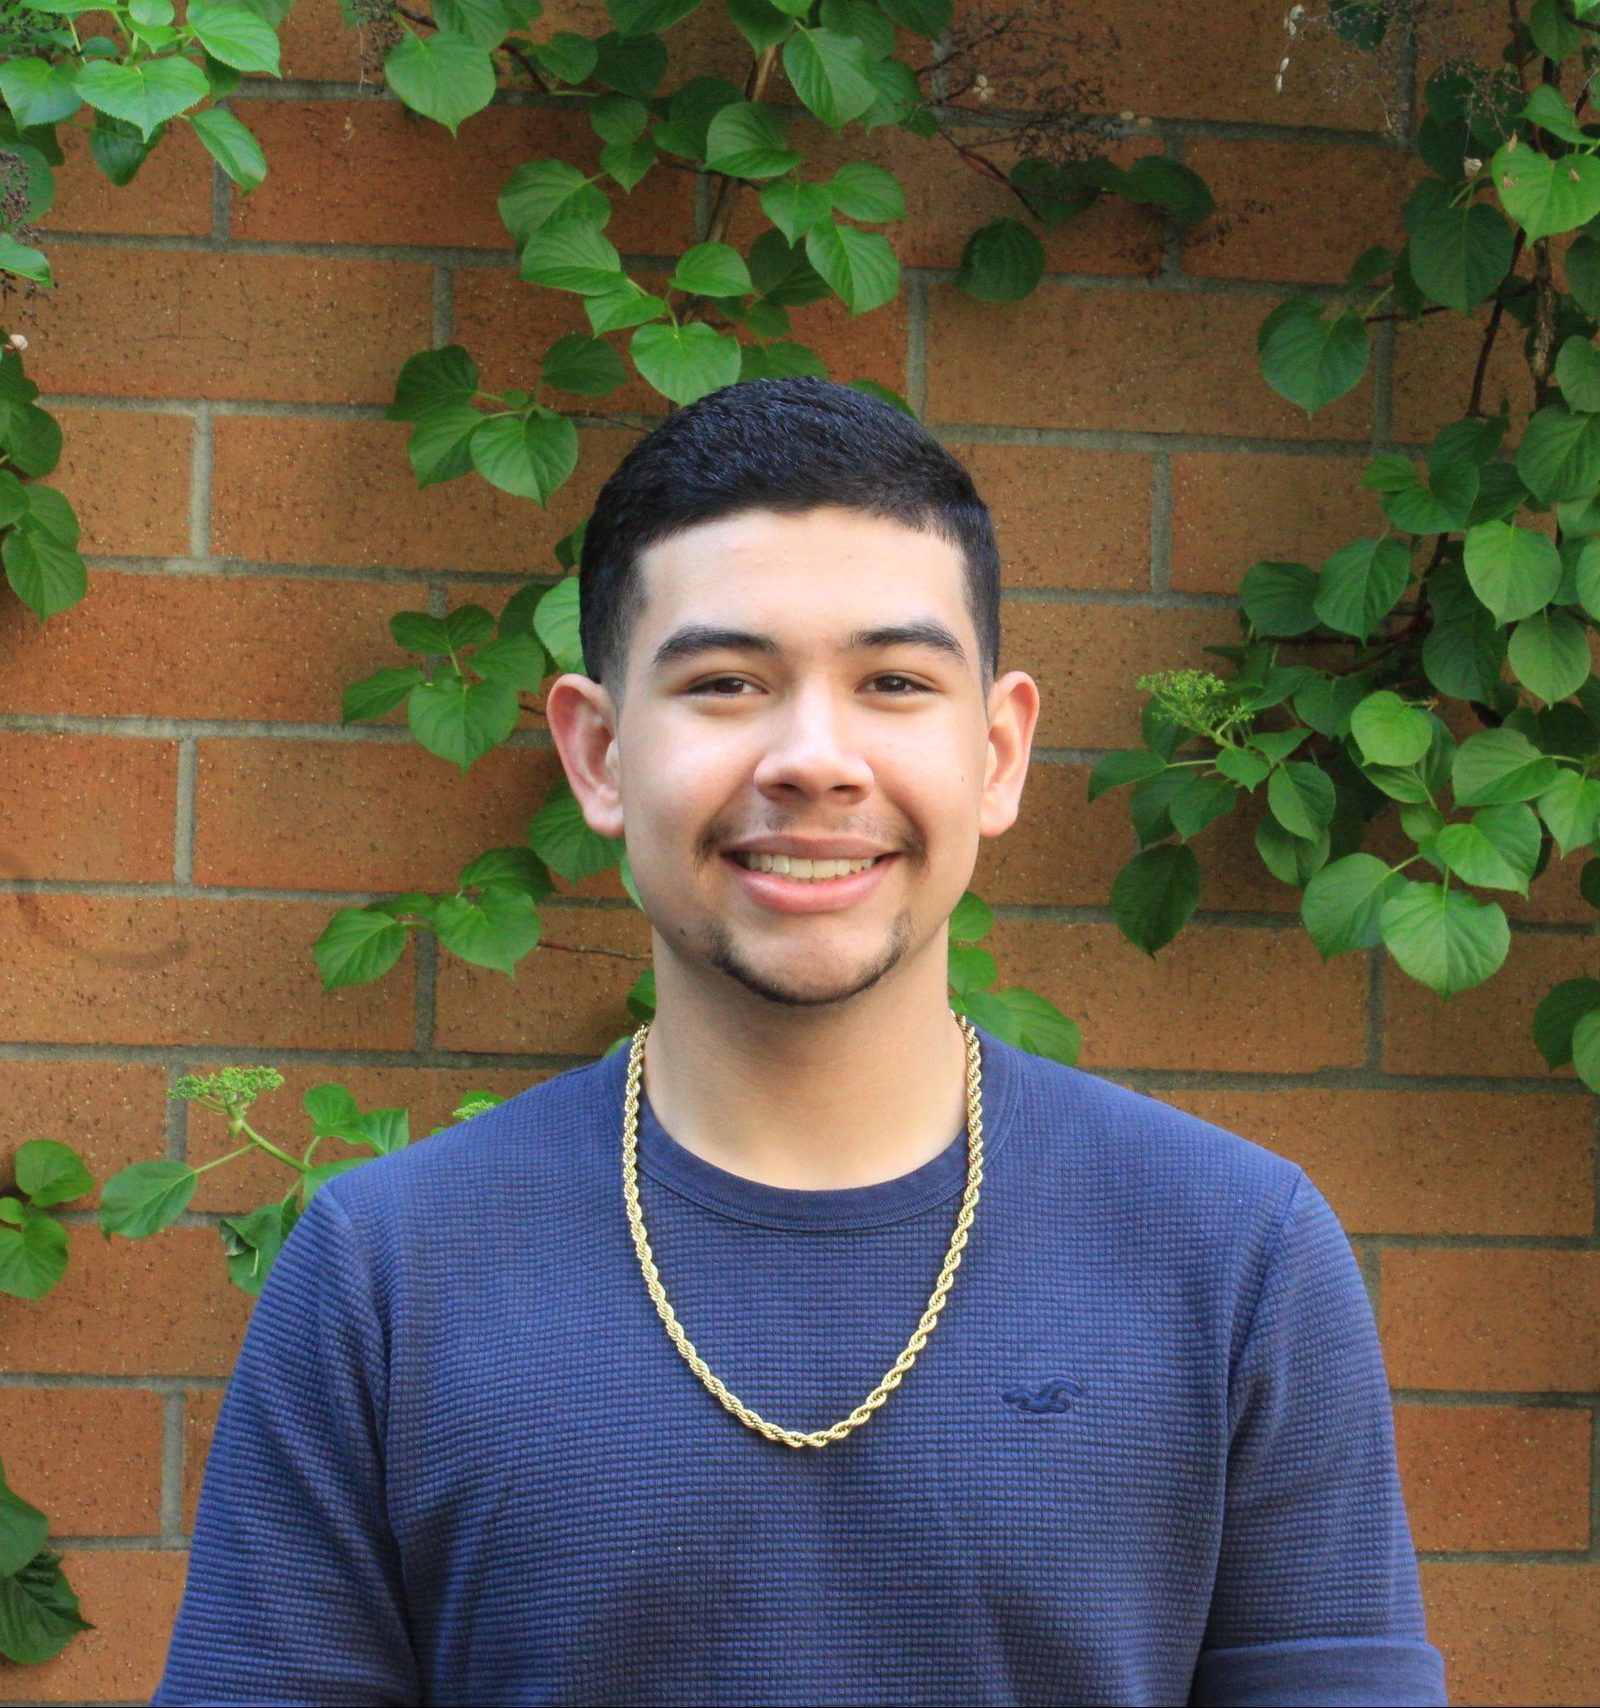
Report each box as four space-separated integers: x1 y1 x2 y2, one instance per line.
635 506 975 639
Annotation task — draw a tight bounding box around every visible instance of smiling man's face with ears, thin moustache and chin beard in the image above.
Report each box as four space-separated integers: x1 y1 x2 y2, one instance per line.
552 507 1036 1004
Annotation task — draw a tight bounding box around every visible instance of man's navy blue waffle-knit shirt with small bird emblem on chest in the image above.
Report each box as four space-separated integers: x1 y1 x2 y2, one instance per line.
154 1033 1446 1705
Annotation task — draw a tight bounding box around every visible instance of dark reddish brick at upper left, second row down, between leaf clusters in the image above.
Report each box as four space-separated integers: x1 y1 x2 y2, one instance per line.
231 101 695 256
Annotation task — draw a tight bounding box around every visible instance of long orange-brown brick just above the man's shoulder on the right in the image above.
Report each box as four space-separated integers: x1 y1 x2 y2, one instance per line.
1161 1086 1595 1235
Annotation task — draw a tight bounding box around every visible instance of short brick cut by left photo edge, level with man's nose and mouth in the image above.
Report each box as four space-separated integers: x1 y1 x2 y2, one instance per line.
0 731 178 883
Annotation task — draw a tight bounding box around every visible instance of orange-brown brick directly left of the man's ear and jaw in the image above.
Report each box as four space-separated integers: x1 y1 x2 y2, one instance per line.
195 741 623 897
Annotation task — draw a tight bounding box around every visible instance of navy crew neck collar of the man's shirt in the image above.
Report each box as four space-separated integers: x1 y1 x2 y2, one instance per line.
613 1027 1016 1233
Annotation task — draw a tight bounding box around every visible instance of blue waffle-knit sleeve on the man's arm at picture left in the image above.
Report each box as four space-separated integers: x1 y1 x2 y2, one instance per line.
152 1187 420 1705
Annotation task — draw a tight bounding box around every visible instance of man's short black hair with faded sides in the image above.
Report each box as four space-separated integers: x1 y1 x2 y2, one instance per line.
577 376 1001 685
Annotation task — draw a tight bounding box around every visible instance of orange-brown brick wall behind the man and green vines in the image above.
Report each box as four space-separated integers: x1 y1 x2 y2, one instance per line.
0 0 1600 1703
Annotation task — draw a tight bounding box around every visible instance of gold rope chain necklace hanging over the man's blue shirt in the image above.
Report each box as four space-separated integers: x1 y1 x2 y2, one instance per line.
622 1009 984 1447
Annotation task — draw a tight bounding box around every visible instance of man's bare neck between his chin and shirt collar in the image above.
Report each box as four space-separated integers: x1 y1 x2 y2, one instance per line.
644 936 966 1192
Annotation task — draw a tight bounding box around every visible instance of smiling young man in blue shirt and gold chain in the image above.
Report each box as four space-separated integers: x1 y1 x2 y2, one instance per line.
155 379 1445 1705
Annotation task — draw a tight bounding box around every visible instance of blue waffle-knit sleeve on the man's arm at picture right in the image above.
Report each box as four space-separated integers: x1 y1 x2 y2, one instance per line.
1190 1173 1448 1708
